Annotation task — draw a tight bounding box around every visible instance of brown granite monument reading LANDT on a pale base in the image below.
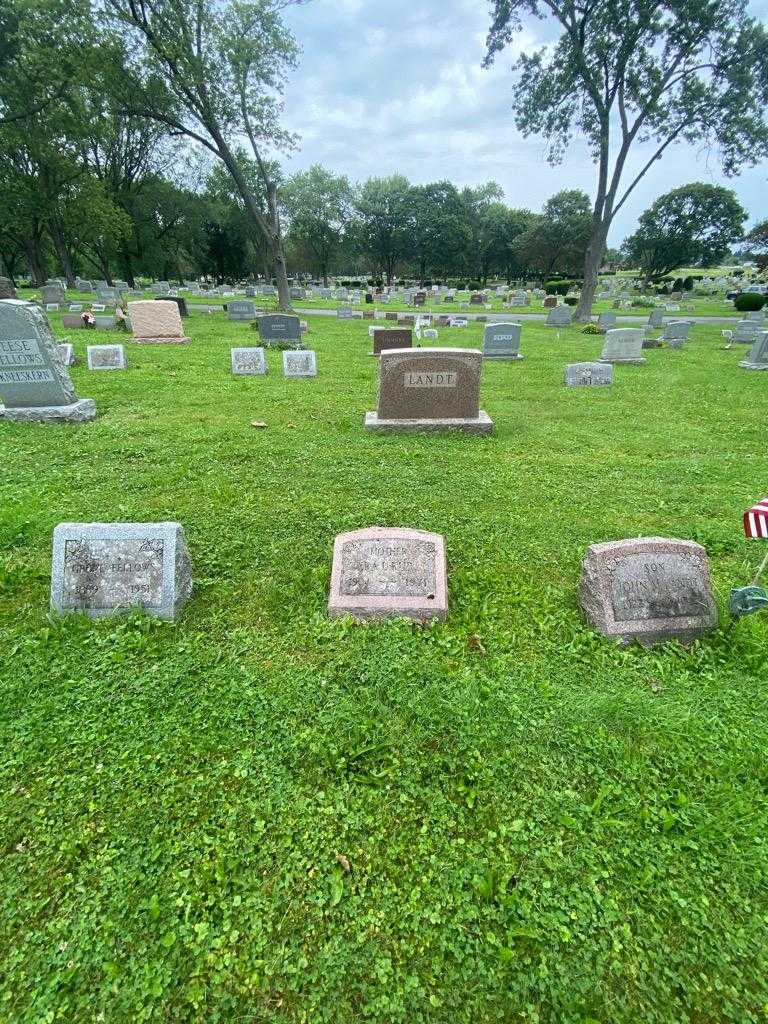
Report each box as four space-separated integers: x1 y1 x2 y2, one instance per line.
365 348 494 434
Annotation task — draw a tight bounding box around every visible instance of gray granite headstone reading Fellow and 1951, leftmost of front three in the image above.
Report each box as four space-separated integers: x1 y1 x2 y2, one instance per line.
50 522 193 620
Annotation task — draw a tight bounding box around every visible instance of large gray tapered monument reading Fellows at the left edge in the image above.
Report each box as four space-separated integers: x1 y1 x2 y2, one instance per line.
0 299 96 423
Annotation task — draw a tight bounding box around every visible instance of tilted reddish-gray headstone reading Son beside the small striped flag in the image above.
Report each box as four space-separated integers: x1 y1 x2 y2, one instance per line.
580 537 718 646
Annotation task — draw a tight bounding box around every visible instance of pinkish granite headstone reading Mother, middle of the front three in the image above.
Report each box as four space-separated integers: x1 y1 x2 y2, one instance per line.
328 526 447 622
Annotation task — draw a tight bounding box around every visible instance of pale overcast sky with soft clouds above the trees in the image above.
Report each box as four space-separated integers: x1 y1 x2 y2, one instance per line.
285 0 768 245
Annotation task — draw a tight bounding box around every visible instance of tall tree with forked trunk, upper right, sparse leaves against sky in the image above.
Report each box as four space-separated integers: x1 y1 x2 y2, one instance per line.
485 0 768 319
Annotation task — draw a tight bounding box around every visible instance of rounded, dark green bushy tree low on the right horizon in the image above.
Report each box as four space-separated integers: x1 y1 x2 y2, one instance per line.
624 181 746 282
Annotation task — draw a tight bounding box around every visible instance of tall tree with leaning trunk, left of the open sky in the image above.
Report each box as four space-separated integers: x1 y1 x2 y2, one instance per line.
100 0 301 308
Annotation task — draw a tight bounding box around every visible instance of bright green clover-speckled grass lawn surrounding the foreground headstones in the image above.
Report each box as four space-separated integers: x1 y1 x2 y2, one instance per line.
0 314 768 1024
